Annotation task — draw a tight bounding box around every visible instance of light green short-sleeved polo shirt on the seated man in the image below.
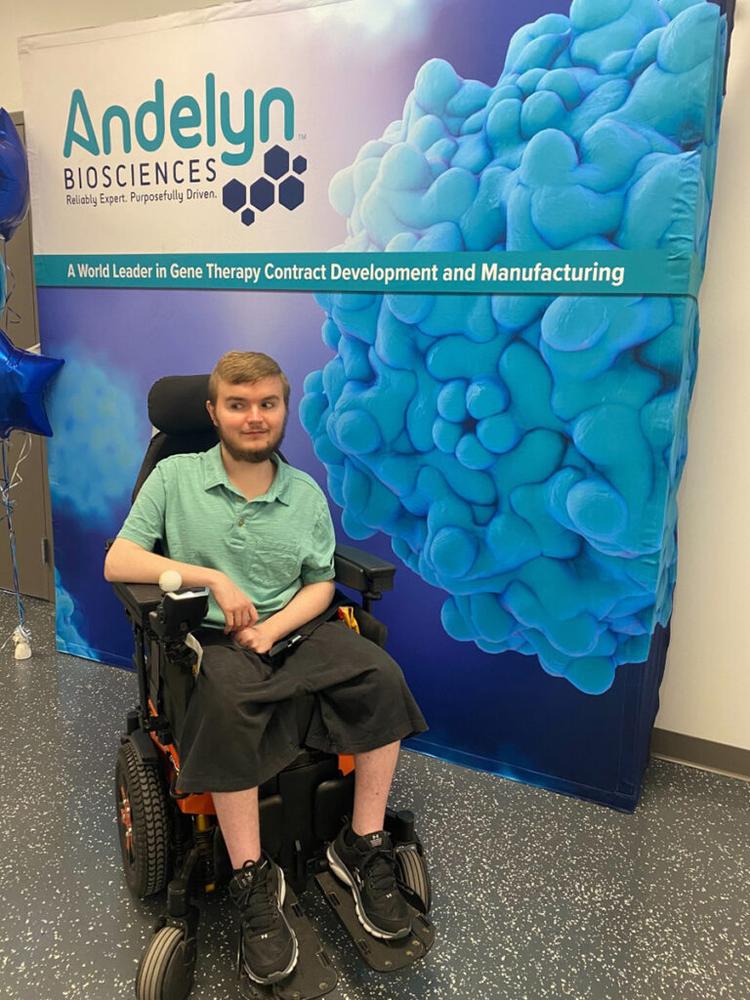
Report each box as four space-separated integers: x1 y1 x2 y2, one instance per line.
118 445 335 627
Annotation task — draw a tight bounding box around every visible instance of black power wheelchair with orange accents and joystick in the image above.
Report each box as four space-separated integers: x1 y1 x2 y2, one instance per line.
108 375 434 1000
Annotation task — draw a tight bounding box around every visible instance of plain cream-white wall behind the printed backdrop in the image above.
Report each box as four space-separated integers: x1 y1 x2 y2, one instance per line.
0 0 750 750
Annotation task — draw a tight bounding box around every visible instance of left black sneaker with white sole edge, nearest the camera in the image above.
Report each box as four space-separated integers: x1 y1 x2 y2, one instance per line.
229 854 298 984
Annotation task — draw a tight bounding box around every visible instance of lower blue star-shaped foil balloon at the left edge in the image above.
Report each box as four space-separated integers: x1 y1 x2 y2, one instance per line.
0 330 63 438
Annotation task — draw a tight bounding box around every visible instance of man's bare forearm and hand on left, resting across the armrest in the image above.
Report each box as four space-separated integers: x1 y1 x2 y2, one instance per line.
104 538 258 641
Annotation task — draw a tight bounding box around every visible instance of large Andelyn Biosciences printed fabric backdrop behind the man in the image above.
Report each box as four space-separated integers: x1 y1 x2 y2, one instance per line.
21 0 727 808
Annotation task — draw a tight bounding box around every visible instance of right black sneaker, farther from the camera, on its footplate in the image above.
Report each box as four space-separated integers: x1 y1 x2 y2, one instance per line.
328 824 412 940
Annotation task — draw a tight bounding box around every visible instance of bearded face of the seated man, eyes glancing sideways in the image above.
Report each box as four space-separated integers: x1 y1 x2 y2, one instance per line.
206 375 287 462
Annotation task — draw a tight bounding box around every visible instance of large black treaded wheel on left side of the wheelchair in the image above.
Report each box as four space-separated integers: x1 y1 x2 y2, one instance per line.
115 741 169 899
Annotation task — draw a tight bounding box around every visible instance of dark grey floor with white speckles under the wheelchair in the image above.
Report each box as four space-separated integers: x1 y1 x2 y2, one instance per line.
0 594 750 1000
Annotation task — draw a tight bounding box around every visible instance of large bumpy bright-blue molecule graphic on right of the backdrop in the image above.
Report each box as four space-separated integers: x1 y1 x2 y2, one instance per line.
300 0 725 694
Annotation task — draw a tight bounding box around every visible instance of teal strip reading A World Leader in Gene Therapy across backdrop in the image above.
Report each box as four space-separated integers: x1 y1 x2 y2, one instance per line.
34 250 702 296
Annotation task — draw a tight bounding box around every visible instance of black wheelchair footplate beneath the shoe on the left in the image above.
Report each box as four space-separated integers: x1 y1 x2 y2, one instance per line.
237 883 341 1000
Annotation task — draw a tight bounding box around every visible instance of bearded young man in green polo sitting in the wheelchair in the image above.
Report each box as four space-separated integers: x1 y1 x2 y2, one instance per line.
104 351 427 983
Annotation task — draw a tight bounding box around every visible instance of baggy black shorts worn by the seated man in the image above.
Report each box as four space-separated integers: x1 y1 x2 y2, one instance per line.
176 621 427 792
